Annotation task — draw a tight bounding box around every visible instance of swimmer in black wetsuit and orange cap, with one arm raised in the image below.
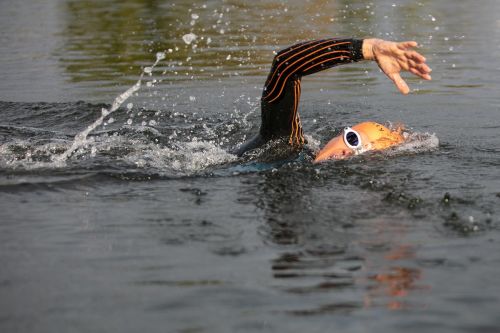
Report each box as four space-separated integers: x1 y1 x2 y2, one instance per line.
235 38 431 162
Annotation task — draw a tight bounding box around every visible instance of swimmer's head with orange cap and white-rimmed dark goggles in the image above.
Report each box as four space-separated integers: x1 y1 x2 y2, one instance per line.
314 121 404 163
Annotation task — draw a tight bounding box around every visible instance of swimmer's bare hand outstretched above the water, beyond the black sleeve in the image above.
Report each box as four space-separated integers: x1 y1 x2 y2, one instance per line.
363 38 432 95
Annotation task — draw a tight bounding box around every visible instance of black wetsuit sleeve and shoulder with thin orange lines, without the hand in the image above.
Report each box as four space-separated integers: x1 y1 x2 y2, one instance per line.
235 38 363 156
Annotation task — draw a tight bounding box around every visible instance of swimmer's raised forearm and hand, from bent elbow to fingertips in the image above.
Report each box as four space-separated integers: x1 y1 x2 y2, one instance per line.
262 38 431 103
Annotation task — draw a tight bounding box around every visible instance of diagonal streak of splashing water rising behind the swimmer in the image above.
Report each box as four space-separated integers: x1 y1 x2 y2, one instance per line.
52 52 165 166
